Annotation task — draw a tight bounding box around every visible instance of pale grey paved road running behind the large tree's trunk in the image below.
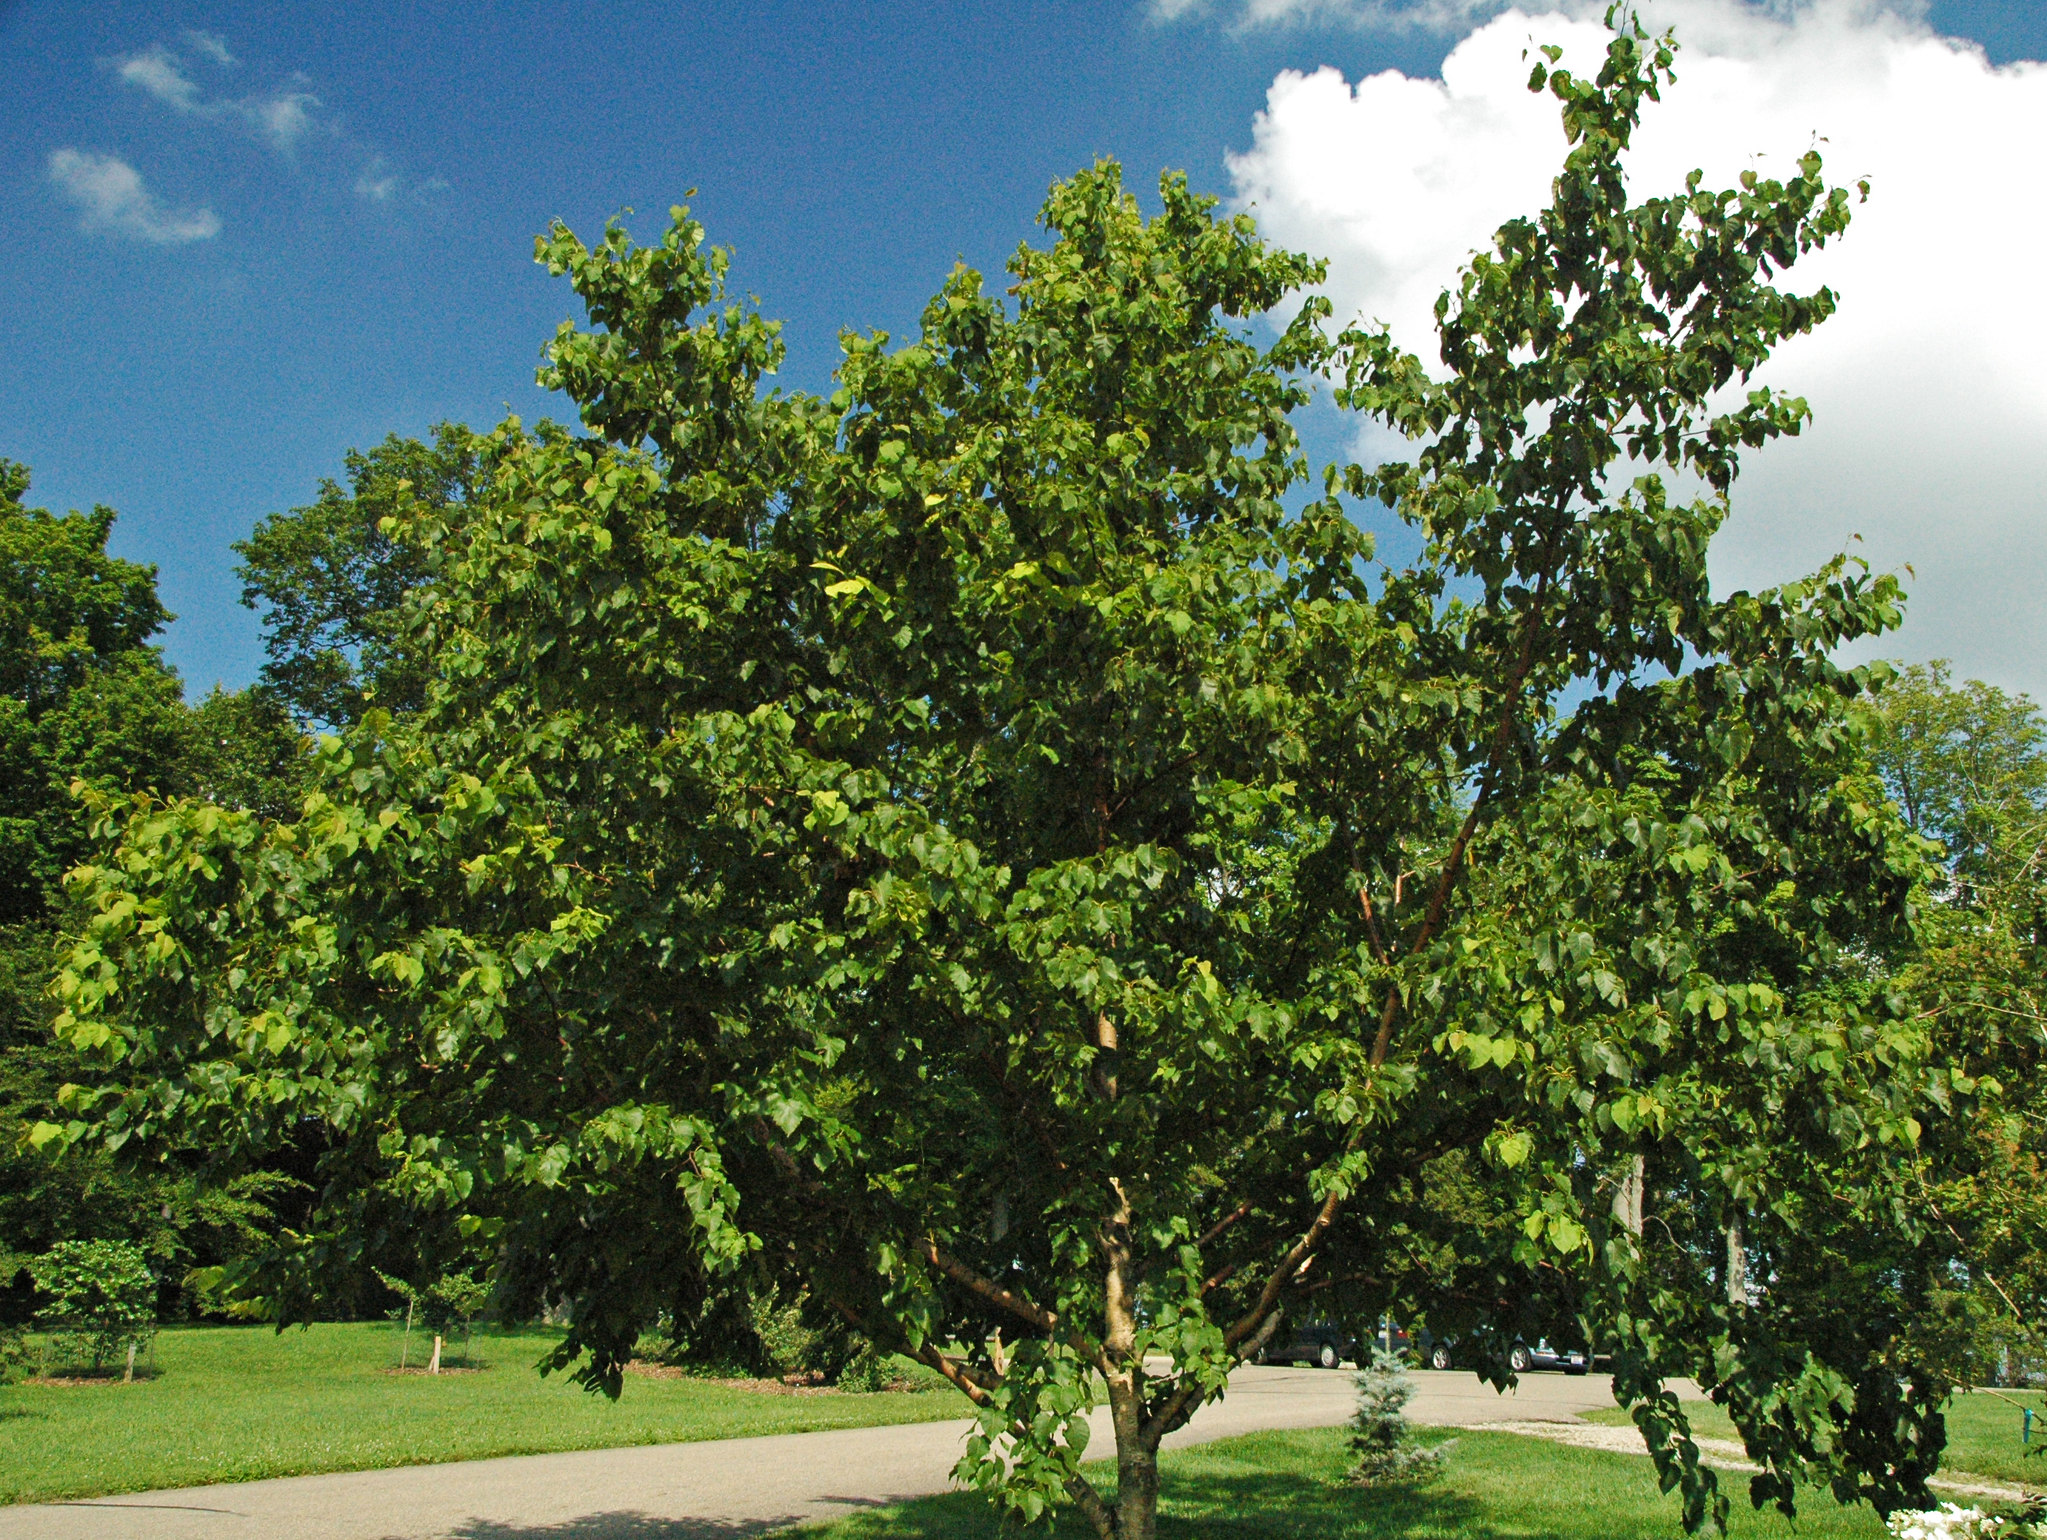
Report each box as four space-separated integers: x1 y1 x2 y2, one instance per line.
0 1366 1613 1540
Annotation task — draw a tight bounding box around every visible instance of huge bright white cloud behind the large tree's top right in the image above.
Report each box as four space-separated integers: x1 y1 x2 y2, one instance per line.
1220 0 2047 694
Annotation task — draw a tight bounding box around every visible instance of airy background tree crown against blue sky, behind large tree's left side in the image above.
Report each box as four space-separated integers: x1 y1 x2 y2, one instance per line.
235 422 487 727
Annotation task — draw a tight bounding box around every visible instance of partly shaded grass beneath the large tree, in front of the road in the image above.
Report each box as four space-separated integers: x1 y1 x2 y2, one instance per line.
804 1429 1883 1540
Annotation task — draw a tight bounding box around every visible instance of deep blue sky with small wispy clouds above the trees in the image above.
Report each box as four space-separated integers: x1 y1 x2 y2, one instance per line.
0 0 2047 688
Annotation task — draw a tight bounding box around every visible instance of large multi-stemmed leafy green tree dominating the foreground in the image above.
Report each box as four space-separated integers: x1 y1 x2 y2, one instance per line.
51 29 1943 1540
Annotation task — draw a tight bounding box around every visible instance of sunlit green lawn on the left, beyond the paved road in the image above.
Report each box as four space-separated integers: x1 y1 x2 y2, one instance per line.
0 1323 968 1503
